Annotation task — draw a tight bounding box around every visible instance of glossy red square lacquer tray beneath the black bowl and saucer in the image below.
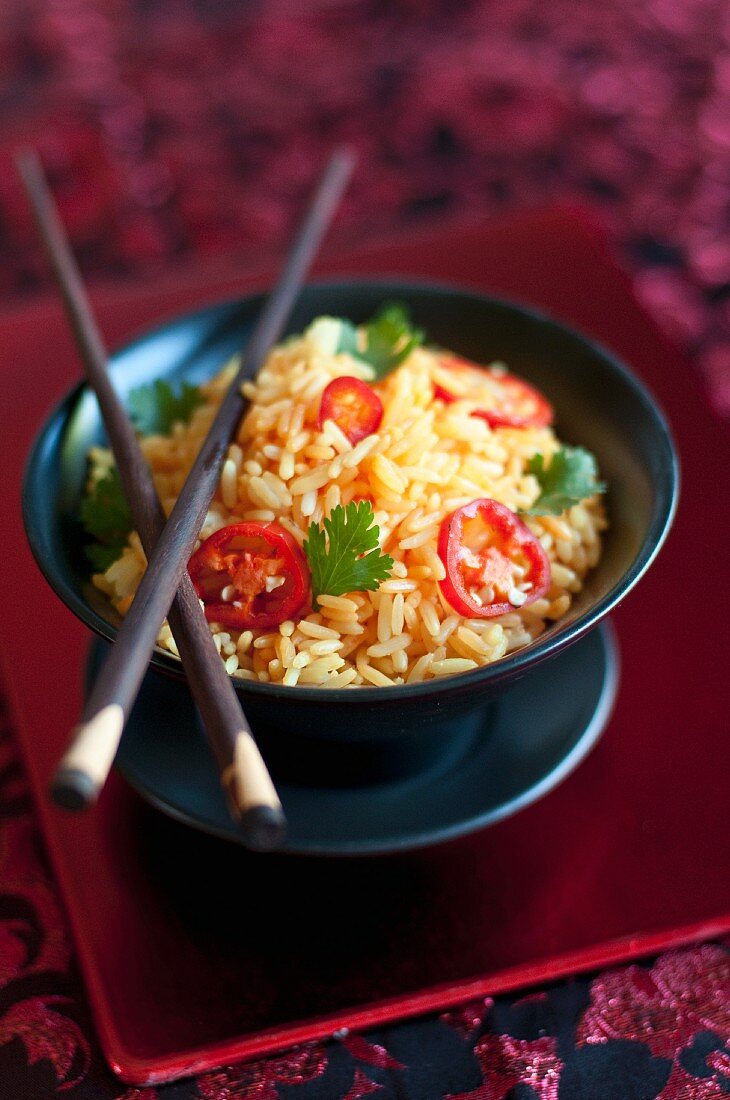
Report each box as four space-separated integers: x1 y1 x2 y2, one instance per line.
0 211 730 1084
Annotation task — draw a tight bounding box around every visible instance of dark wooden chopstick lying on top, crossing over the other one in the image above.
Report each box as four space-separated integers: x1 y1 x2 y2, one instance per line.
33 150 354 818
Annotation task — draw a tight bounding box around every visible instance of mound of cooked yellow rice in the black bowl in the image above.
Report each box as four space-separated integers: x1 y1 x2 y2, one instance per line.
92 314 606 688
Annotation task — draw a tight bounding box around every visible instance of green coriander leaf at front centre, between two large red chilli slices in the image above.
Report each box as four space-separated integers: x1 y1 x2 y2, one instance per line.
305 501 392 602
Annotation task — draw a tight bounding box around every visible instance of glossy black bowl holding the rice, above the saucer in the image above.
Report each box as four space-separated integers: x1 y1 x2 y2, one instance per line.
23 281 678 774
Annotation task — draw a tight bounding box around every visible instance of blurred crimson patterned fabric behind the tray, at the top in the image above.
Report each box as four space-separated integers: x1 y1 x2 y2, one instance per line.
0 0 730 414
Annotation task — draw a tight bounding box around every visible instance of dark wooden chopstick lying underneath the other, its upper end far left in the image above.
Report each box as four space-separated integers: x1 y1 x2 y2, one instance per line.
18 152 286 850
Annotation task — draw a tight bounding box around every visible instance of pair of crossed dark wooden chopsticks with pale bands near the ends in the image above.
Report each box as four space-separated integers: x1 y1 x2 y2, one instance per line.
18 150 354 850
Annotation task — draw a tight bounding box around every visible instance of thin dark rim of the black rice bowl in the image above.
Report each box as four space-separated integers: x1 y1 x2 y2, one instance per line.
22 275 679 705
